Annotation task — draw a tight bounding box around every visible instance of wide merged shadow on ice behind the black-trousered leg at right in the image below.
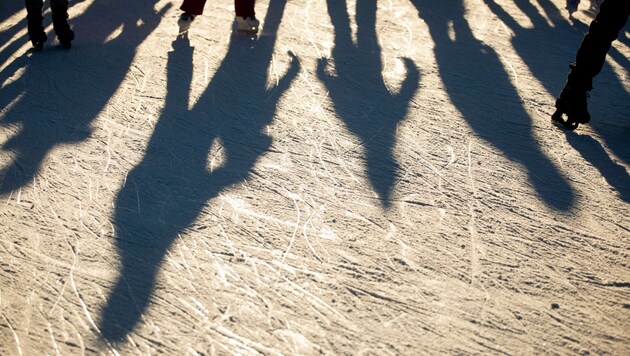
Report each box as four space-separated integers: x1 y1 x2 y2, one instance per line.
484 0 630 170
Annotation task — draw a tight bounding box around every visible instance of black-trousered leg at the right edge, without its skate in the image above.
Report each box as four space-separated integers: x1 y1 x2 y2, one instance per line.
567 0 630 91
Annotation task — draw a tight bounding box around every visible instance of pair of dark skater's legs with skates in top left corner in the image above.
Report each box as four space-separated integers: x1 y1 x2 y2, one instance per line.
24 0 74 49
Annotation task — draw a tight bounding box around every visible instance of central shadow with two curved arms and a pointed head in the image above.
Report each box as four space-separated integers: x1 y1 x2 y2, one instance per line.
317 0 420 208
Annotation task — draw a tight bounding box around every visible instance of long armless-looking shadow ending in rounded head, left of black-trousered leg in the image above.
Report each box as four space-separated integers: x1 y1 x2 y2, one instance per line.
411 0 575 211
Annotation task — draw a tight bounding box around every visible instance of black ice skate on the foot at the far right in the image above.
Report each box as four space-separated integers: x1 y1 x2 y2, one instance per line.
551 86 591 131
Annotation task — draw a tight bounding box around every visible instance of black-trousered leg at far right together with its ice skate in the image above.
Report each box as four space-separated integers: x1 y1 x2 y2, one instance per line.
552 0 630 130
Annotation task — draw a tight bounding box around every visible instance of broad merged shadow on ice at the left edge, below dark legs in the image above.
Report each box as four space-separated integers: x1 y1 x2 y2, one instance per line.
0 0 169 194
